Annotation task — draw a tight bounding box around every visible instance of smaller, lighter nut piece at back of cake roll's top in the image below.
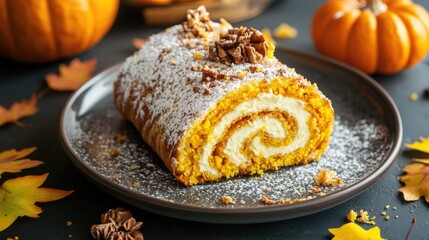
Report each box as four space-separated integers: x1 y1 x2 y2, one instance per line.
182 6 213 37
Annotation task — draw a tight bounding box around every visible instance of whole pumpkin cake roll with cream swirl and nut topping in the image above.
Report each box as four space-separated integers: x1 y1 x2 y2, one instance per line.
114 7 334 186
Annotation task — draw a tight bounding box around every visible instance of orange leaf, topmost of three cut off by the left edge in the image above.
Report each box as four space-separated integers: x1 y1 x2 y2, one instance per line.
0 94 39 126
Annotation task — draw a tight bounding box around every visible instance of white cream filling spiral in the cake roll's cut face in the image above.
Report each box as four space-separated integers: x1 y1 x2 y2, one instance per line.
199 93 310 175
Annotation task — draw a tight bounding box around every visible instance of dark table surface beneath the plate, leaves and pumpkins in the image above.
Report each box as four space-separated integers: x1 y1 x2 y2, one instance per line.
0 0 429 239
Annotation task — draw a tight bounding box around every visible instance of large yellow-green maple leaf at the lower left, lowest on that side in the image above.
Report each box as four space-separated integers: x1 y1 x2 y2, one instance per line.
0 173 73 231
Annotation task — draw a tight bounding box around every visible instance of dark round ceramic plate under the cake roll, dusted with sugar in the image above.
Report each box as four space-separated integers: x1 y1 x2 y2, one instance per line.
61 49 402 223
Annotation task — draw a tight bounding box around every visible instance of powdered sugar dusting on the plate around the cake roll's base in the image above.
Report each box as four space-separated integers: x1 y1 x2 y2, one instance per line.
71 96 392 208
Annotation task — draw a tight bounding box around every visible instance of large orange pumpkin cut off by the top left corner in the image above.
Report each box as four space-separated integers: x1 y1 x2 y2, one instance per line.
0 0 119 63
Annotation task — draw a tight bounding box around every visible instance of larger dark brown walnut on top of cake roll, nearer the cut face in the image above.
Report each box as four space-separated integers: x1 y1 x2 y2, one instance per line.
209 27 268 64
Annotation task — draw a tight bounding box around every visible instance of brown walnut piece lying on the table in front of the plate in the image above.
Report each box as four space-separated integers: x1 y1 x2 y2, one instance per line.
91 208 143 240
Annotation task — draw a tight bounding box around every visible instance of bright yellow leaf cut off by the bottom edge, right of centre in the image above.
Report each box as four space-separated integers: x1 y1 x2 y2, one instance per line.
329 222 383 240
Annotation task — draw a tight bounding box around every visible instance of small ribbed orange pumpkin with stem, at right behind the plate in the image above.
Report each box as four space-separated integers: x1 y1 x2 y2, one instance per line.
312 0 429 74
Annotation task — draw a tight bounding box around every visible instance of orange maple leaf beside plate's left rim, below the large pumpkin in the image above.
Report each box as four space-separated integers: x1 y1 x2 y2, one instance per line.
45 58 97 91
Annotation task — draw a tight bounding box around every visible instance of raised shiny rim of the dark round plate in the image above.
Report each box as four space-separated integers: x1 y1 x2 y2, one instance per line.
60 48 403 223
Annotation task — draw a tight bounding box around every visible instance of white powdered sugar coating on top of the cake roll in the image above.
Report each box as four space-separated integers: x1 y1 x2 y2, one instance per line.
113 22 300 146
